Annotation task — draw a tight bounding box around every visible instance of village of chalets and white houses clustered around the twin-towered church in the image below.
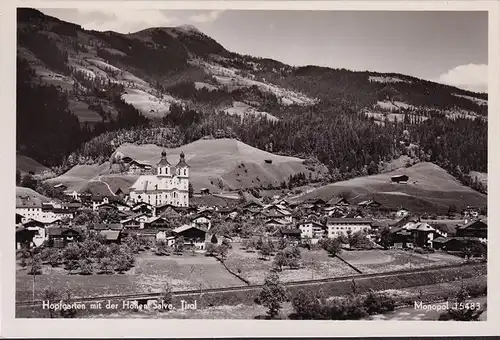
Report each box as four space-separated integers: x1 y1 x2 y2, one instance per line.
16 152 487 266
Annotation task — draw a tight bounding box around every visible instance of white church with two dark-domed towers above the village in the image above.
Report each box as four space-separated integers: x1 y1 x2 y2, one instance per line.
129 150 189 207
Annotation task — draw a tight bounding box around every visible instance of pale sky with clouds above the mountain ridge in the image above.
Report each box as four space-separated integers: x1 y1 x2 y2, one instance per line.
41 8 488 92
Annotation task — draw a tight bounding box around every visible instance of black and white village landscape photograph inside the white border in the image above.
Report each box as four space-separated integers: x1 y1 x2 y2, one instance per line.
1 1 498 338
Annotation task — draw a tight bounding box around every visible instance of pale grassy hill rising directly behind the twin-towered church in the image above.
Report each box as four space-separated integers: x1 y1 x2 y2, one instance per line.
49 139 326 192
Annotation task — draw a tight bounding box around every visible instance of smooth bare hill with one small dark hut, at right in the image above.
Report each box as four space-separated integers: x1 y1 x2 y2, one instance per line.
298 162 487 213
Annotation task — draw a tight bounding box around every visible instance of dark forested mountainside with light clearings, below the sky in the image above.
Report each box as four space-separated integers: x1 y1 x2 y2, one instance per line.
17 9 488 191
